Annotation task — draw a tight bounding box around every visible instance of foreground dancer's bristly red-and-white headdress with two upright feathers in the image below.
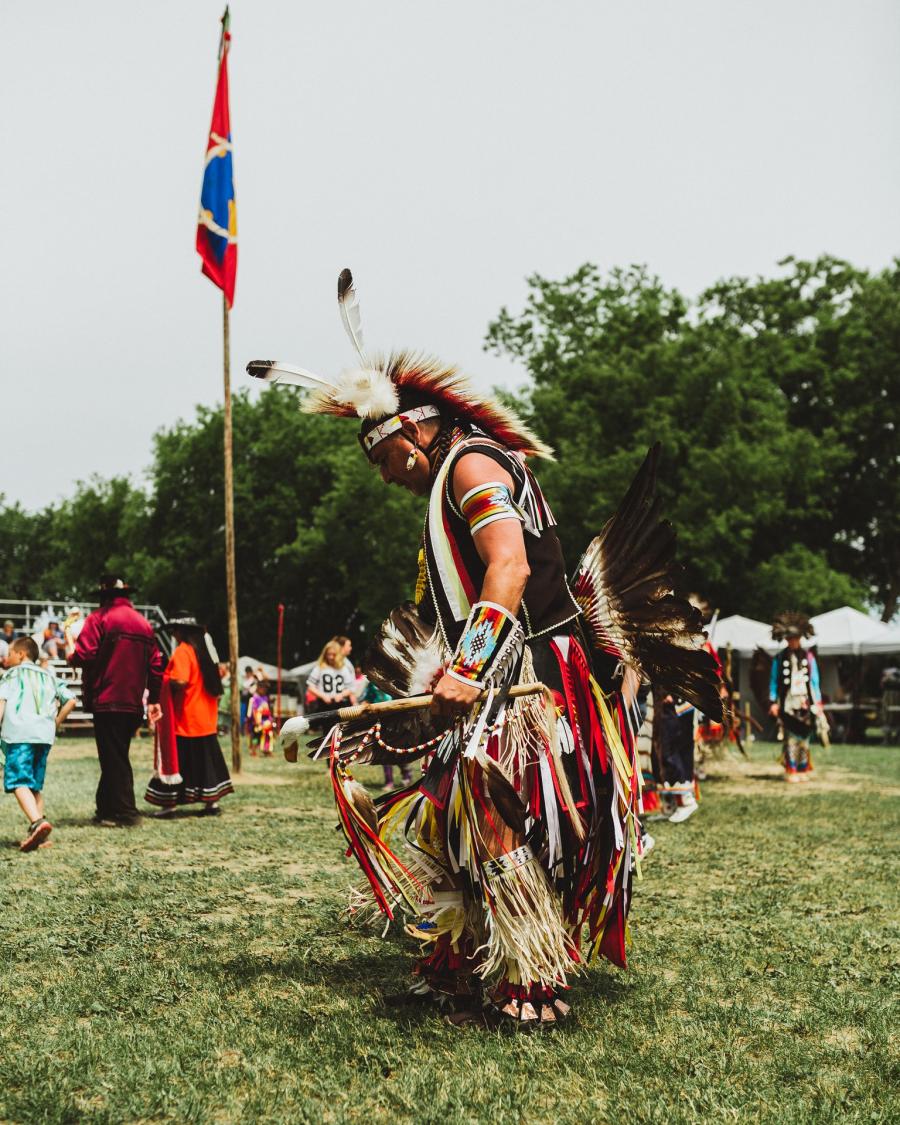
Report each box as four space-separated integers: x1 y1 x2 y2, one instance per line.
248 270 554 458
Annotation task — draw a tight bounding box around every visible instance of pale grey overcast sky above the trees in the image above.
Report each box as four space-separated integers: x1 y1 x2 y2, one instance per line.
0 0 900 507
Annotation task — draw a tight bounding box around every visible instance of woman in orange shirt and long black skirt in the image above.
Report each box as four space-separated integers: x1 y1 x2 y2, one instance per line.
145 614 234 816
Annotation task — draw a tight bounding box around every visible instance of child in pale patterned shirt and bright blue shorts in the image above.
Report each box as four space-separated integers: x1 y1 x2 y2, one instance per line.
0 637 75 852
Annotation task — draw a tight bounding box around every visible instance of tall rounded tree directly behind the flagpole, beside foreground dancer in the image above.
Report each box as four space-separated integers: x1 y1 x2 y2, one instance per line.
143 389 422 663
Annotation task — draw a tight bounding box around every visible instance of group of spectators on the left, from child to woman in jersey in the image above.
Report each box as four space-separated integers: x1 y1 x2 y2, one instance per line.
0 589 398 852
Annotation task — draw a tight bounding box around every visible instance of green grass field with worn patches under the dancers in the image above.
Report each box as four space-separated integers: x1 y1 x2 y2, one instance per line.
0 740 900 1125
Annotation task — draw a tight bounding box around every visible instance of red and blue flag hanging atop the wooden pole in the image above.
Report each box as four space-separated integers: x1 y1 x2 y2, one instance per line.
197 8 237 308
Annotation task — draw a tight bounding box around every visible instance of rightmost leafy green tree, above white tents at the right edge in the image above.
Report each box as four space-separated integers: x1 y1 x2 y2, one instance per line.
704 257 900 620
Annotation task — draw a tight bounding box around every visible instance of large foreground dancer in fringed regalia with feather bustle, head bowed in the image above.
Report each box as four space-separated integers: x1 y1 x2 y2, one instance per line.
249 270 718 1027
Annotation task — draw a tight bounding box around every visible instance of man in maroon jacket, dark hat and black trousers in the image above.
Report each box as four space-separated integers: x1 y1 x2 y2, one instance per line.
65 576 164 828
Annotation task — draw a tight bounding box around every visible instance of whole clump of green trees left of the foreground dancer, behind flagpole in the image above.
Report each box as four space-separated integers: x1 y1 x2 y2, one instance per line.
0 389 424 664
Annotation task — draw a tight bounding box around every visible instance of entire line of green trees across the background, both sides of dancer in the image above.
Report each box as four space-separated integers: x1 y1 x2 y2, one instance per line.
0 257 900 663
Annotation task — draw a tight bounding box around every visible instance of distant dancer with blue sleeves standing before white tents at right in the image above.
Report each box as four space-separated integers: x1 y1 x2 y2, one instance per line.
768 613 828 782
